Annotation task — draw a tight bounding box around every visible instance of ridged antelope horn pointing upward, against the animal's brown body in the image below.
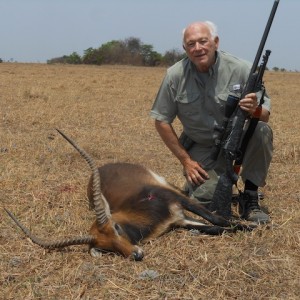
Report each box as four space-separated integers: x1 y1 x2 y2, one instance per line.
56 129 111 226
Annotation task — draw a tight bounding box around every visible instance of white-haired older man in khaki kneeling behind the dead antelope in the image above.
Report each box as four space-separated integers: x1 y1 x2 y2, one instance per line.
150 21 273 223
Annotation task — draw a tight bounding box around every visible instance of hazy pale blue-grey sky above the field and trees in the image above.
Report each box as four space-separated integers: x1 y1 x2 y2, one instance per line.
0 0 300 71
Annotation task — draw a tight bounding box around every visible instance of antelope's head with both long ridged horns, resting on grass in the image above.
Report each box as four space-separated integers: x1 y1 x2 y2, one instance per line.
5 129 144 260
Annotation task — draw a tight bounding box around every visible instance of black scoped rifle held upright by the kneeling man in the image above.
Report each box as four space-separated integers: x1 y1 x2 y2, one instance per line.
210 0 279 218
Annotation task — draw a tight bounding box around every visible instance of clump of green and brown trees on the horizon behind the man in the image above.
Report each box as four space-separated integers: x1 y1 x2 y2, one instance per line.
47 37 185 66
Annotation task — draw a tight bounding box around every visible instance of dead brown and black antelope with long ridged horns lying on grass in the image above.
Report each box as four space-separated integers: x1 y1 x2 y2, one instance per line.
6 130 252 260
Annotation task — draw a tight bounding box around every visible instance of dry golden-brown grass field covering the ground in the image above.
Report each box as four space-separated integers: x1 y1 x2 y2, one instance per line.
0 64 300 299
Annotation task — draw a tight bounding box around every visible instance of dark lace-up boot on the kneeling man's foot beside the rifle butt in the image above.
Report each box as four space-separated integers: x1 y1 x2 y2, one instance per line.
238 190 270 224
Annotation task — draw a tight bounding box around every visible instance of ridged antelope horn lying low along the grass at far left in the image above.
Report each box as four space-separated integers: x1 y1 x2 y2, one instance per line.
4 208 94 249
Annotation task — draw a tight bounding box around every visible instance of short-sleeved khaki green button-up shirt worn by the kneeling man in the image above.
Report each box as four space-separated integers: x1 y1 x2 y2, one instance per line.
150 51 270 149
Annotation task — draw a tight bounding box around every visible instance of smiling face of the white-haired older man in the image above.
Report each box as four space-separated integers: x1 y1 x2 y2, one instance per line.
184 23 219 72
